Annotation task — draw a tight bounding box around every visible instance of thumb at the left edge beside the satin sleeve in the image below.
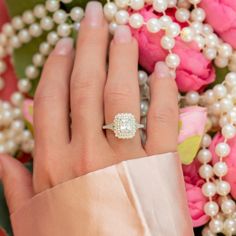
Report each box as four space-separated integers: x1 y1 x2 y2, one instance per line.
0 155 34 214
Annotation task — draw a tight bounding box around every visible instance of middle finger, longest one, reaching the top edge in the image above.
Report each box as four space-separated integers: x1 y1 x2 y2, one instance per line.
71 2 108 142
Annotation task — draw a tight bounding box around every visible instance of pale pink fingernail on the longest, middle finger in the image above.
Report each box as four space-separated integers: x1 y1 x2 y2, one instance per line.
85 2 104 27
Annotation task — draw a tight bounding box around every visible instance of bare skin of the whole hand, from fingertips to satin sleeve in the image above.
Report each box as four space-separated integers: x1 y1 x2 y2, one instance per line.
0 2 178 218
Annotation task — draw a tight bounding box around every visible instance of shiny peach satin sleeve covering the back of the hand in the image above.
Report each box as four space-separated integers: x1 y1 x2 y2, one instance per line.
11 153 193 236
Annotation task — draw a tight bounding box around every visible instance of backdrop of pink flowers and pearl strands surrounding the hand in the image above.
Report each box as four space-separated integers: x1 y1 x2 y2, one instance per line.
0 0 236 236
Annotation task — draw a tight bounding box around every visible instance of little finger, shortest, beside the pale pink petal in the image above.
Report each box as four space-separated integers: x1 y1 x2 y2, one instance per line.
145 62 179 155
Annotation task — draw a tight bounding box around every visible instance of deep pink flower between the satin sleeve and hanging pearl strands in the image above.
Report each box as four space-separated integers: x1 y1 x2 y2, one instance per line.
183 160 209 227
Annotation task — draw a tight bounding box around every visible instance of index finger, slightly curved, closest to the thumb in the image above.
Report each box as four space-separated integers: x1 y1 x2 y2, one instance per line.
34 38 74 147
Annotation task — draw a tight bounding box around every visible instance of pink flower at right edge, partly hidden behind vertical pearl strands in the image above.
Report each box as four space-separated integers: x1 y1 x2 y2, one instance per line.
210 133 236 199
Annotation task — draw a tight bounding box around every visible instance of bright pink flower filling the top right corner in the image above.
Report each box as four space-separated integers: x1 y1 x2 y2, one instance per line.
200 0 236 48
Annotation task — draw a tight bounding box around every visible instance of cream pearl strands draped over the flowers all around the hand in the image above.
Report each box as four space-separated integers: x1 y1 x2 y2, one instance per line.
0 0 236 233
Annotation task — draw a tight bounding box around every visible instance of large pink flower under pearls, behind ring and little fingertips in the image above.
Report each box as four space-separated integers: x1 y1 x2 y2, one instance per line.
132 6 215 92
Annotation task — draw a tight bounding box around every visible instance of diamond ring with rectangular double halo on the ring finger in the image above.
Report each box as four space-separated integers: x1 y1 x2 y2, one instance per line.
103 113 144 139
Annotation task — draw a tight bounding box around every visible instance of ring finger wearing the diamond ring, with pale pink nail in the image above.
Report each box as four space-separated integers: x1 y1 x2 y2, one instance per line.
104 26 144 156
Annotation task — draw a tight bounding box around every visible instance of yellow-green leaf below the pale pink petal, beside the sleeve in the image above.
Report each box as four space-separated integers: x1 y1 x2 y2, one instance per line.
178 135 202 165
